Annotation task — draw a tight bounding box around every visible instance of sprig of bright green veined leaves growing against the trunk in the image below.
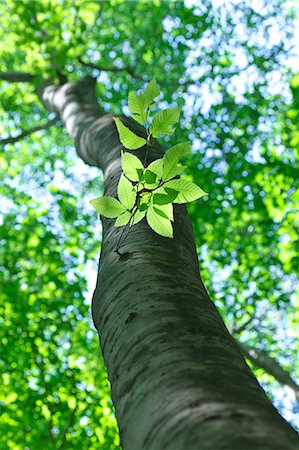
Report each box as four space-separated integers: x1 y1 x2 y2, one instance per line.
90 80 207 238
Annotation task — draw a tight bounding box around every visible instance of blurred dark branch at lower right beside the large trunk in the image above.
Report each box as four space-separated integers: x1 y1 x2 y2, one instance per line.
238 342 299 400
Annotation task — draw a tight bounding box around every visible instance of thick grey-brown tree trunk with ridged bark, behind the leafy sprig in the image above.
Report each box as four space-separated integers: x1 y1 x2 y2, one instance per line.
43 79 298 450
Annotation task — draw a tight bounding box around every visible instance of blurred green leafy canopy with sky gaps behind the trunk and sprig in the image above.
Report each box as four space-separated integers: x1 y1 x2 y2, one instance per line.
1 1 298 448
